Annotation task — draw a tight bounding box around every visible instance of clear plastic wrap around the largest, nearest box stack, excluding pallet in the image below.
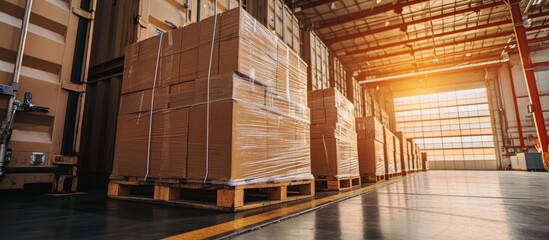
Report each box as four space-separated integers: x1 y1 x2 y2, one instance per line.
112 9 312 186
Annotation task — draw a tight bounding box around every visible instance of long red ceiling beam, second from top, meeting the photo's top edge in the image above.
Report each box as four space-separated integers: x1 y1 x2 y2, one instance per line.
324 1 505 46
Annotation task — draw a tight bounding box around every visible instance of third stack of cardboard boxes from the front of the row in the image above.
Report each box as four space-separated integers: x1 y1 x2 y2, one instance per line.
356 117 385 179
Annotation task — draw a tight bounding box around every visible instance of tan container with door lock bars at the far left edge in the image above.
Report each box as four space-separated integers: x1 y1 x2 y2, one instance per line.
0 0 95 190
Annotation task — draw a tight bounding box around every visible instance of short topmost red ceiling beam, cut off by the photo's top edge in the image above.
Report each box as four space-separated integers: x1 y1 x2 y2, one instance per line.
312 0 429 29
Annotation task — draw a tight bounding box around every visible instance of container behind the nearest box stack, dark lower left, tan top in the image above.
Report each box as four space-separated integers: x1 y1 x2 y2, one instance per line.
78 0 239 184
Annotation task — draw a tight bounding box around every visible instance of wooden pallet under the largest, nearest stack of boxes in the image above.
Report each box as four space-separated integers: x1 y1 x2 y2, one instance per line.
108 177 315 212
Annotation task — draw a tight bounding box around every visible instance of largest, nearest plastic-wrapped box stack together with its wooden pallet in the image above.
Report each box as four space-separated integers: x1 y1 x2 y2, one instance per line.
108 9 314 211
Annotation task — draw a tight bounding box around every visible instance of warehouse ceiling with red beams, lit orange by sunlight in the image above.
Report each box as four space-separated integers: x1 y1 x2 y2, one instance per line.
285 0 549 80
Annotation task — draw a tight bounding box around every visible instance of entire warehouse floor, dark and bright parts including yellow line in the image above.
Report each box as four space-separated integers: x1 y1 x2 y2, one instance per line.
0 171 549 239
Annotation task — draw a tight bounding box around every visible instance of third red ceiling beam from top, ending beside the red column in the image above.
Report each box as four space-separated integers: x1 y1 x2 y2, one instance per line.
345 20 511 56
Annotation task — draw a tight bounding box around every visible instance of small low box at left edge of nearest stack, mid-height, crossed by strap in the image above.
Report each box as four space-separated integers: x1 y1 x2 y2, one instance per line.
118 87 169 114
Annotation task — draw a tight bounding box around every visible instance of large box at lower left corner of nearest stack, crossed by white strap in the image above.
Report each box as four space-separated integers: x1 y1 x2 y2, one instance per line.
112 108 189 178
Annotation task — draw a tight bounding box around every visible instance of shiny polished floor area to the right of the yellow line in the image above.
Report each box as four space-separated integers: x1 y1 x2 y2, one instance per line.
236 171 549 239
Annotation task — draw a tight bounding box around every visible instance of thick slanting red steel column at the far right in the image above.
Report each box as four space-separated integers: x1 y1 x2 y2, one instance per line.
507 0 547 153
